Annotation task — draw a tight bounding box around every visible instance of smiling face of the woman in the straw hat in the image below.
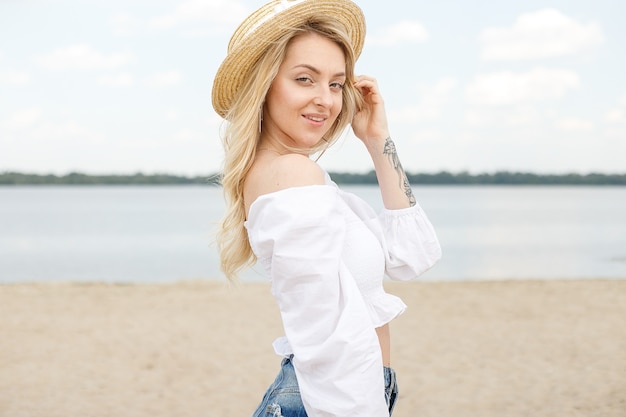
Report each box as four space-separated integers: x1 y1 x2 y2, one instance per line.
261 33 346 153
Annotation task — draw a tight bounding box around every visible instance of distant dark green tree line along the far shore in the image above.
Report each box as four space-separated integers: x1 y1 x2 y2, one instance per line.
0 171 626 185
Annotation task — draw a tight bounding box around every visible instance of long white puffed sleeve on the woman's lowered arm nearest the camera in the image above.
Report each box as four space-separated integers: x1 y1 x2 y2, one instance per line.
246 185 389 417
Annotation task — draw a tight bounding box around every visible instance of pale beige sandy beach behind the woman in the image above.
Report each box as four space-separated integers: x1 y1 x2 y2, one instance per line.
0 280 626 417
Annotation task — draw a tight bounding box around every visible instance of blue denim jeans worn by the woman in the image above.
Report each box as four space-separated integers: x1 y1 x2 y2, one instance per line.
253 355 398 417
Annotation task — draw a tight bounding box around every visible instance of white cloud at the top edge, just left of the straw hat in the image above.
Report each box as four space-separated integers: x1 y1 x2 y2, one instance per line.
149 0 248 29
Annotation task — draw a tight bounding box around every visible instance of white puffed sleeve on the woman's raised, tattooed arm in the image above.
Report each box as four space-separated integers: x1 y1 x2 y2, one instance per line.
378 204 441 281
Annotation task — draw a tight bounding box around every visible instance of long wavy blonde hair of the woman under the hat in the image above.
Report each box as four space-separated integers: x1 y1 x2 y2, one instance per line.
217 16 362 281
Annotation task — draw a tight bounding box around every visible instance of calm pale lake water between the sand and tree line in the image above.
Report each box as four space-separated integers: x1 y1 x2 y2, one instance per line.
0 186 626 283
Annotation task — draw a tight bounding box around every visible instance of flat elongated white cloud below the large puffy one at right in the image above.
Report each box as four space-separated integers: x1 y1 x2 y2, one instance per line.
465 68 580 106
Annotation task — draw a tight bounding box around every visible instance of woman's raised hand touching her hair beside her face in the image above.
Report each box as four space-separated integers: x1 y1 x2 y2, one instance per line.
352 75 389 144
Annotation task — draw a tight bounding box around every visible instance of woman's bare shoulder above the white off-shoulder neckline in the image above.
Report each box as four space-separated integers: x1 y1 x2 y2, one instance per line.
244 154 325 212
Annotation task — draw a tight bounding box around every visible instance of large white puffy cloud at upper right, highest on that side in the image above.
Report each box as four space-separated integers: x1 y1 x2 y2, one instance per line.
479 9 604 61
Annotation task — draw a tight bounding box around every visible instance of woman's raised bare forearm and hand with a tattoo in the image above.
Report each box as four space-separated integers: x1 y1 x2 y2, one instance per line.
352 76 416 209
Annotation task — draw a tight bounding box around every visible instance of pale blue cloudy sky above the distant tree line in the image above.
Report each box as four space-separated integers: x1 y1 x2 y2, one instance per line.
0 0 626 176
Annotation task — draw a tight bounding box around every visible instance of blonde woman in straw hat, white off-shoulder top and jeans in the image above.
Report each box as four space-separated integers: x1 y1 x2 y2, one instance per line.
213 0 441 417
